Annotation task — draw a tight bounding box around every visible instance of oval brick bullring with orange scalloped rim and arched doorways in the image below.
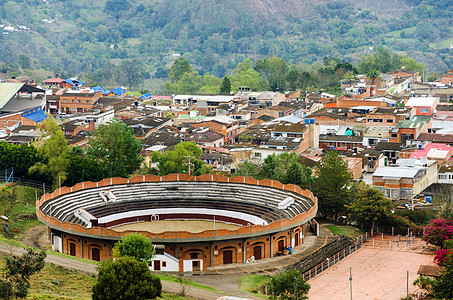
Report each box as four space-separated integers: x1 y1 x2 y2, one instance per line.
36 174 318 272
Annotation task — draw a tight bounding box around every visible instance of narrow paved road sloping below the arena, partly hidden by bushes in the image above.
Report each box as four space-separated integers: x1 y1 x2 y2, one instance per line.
0 243 225 300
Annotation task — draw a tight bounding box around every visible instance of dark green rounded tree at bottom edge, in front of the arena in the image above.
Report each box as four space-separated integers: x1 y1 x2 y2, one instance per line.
92 257 162 300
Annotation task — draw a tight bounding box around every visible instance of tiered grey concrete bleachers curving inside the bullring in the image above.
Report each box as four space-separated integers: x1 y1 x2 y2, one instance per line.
40 181 314 225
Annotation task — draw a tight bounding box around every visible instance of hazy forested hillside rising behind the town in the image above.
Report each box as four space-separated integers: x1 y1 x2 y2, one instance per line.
0 0 453 82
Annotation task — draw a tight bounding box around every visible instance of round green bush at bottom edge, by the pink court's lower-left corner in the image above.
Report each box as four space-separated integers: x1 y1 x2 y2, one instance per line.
269 270 310 300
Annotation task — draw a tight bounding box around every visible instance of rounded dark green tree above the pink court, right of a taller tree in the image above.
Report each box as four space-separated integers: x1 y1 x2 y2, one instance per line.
346 185 392 230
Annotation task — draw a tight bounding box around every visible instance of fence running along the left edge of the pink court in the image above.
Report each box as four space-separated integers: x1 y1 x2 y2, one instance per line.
302 231 373 281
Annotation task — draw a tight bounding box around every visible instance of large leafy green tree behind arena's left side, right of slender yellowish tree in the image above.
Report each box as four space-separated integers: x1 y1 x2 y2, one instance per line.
87 120 142 177
